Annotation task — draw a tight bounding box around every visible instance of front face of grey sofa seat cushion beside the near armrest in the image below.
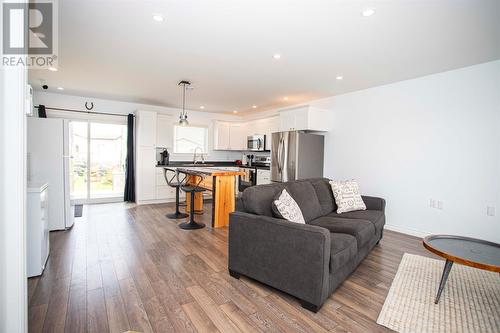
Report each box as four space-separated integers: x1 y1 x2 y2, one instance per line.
330 233 358 273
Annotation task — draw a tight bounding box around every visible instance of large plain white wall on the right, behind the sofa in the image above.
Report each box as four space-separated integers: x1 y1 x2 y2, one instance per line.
310 61 500 242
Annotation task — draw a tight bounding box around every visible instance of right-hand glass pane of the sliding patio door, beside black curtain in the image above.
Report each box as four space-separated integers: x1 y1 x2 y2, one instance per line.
90 123 127 198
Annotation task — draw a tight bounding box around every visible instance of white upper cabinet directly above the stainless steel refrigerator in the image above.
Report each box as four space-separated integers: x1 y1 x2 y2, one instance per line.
279 106 328 131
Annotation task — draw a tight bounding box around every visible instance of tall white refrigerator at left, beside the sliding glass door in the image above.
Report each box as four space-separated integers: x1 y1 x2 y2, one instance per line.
28 117 75 230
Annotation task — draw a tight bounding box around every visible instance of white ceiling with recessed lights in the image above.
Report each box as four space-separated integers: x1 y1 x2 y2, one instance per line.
30 0 500 112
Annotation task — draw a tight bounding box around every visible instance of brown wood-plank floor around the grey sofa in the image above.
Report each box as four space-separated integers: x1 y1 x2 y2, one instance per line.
28 204 432 333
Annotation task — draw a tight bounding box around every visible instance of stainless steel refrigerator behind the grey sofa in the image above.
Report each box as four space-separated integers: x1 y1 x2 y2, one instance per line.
271 131 325 182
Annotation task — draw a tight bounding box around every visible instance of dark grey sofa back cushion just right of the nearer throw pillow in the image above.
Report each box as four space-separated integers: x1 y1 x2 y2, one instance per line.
286 181 323 222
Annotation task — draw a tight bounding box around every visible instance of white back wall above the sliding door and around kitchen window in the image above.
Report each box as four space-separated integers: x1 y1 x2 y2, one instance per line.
33 91 247 161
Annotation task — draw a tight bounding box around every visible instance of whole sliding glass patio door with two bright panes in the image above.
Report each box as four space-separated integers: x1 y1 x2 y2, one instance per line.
69 121 127 203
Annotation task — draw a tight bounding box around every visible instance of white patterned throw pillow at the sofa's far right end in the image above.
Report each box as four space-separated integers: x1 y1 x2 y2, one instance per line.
330 179 366 214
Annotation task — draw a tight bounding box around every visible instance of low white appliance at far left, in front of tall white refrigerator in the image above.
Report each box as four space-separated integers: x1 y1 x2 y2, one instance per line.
26 183 50 277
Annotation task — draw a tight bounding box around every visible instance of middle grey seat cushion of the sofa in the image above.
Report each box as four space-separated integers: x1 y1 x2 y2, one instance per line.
309 216 375 249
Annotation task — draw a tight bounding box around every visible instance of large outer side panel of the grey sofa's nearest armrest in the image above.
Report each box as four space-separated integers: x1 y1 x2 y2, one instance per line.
229 212 330 305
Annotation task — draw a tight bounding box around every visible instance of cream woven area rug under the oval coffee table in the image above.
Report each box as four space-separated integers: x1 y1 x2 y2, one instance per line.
377 253 500 333
